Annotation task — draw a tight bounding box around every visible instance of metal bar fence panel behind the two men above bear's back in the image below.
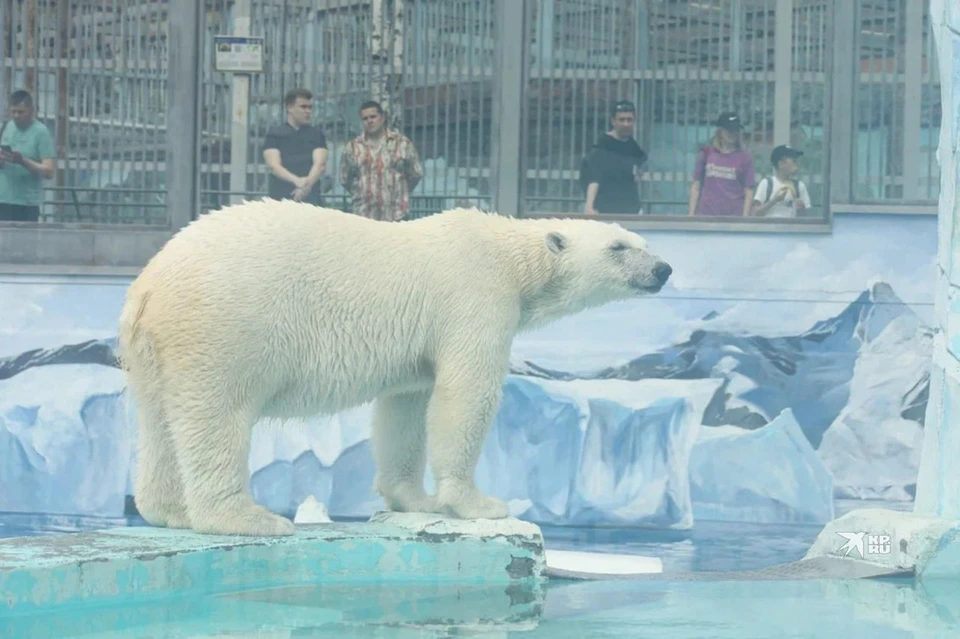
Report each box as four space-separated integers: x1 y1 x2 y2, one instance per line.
201 0 494 214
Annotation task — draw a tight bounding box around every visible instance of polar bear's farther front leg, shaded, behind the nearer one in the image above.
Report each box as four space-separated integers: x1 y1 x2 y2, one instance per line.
371 391 438 512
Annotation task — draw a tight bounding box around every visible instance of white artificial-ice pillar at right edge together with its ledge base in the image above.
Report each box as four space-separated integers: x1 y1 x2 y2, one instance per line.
804 0 960 580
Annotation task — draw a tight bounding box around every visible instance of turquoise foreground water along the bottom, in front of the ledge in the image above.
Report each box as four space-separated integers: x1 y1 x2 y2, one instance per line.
7 580 960 639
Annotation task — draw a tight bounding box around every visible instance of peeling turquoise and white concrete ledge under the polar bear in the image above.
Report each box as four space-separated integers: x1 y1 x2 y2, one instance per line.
0 513 546 616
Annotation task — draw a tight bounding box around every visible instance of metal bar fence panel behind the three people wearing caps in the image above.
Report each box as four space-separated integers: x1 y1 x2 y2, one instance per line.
526 0 826 217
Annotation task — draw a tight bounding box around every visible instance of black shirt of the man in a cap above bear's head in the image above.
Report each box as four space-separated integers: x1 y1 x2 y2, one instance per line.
580 135 647 215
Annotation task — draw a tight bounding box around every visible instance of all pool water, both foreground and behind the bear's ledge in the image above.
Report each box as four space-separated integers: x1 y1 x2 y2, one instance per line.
7 504 960 639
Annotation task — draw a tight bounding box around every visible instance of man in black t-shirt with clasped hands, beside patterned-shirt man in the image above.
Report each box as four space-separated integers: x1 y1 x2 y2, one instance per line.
263 89 328 206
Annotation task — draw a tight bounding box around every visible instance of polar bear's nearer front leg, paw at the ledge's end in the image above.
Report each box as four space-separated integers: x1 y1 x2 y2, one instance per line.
427 371 510 519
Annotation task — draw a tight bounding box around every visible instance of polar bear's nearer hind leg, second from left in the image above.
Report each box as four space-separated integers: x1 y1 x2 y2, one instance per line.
171 399 294 537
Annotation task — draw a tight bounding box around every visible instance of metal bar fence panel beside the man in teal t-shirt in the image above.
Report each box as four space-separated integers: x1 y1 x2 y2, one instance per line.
0 0 167 224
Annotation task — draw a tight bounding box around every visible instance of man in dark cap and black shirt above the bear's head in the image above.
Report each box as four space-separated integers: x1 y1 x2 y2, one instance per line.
580 100 647 215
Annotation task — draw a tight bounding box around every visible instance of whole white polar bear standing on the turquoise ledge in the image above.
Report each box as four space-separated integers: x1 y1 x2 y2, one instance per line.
118 200 671 536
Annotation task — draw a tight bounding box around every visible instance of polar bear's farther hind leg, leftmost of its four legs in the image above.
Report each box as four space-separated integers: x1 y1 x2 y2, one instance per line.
134 400 190 528
